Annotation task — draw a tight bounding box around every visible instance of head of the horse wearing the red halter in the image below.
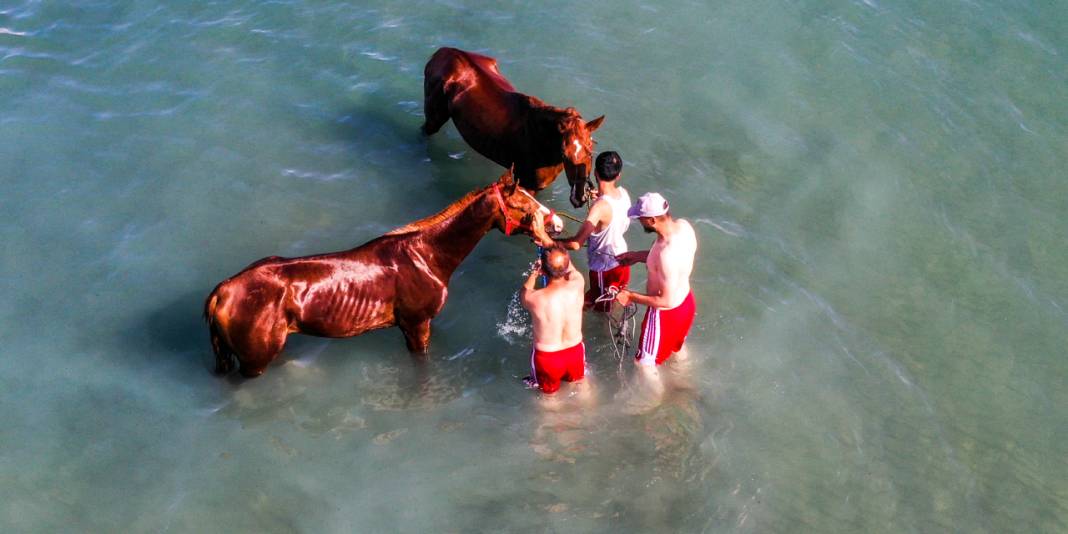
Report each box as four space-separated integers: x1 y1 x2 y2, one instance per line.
490 166 564 242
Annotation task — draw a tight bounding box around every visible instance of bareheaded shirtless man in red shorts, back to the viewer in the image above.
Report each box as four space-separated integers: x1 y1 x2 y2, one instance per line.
519 248 586 393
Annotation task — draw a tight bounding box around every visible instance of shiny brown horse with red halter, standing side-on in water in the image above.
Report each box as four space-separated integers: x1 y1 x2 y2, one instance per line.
204 171 563 377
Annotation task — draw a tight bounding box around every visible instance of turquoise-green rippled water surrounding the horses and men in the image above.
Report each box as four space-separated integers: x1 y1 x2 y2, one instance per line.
0 0 1068 533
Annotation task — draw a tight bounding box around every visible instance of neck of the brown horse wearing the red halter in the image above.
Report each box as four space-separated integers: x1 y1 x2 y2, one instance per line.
415 188 498 280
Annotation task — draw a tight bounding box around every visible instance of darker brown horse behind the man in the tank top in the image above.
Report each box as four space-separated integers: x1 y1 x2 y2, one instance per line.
423 48 604 207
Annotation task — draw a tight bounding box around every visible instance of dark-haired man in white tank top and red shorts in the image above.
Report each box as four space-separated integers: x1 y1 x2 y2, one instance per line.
556 151 630 312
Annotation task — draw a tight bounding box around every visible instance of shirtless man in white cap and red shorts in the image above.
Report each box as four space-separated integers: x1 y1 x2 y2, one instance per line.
616 192 697 365
